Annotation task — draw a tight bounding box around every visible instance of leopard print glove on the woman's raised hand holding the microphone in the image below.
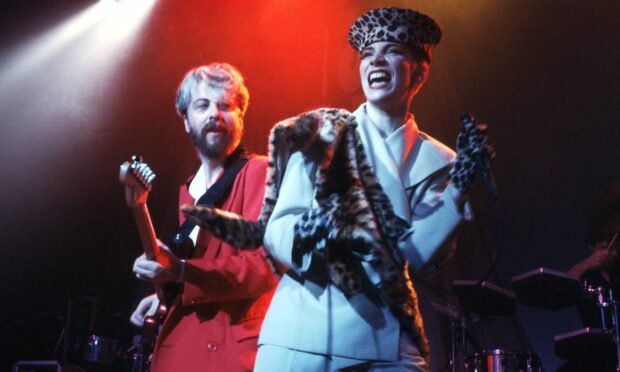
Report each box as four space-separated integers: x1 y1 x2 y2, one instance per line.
449 114 495 194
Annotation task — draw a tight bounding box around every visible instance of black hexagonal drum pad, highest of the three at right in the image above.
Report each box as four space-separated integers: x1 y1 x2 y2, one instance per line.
511 267 584 310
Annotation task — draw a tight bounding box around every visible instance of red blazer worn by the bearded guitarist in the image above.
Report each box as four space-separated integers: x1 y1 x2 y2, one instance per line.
151 158 277 372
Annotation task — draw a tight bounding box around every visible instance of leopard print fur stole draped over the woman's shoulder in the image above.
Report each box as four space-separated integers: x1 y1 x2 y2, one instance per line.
183 109 428 357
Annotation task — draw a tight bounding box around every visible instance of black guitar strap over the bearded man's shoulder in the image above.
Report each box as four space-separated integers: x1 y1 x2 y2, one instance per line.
172 146 250 258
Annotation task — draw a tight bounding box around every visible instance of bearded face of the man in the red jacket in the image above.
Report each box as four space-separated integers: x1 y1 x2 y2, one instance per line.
183 80 243 160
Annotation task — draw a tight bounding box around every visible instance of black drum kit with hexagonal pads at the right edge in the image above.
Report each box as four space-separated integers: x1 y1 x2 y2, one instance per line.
440 268 620 372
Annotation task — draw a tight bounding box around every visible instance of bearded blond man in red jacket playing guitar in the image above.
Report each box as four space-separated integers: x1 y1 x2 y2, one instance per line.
131 63 275 371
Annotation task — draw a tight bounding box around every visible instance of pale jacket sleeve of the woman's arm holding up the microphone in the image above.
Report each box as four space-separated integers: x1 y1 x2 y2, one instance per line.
398 172 472 271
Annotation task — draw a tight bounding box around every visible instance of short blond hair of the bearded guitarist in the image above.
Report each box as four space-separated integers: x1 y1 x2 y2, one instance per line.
176 62 250 117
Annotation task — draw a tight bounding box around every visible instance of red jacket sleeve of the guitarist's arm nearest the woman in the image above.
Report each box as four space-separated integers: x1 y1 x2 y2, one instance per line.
183 160 276 304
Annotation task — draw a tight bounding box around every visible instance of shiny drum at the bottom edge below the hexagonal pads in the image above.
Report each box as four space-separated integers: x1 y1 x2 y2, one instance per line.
467 349 541 372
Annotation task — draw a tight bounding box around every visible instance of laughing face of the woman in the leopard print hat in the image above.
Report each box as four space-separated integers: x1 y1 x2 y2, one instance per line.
360 41 428 105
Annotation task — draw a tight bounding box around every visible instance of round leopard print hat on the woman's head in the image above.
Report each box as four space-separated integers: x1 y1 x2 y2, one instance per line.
349 8 441 62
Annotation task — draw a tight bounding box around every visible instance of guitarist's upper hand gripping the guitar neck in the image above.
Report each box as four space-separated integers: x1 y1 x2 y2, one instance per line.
133 240 185 285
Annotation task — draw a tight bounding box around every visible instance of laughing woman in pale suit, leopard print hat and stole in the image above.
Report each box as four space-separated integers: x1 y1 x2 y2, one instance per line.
248 8 488 372
